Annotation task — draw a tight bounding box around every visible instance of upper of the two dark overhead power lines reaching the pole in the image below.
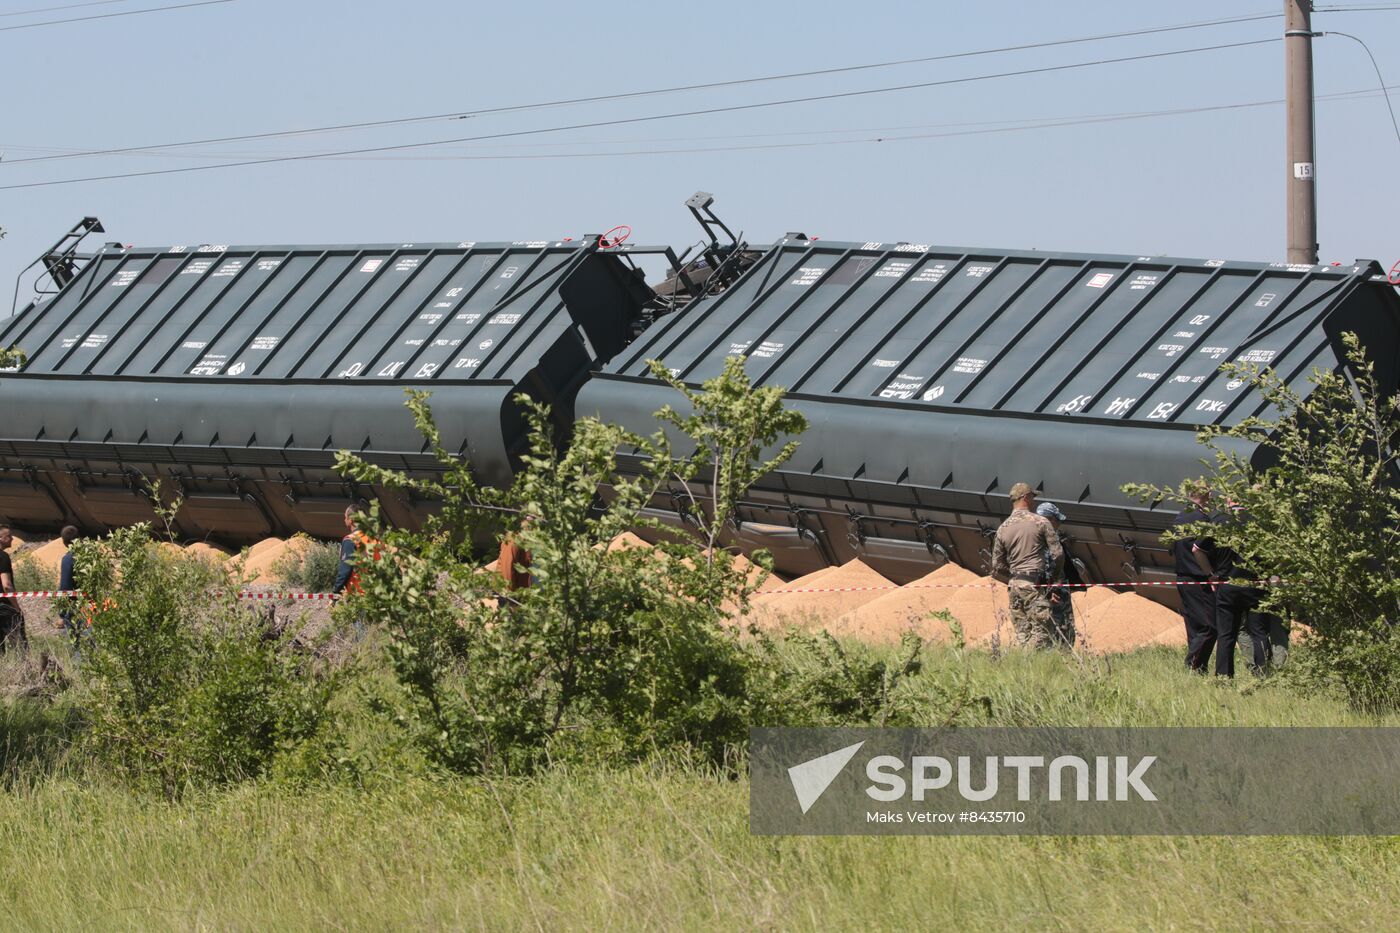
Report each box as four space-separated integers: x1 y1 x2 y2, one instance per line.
6 13 1282 165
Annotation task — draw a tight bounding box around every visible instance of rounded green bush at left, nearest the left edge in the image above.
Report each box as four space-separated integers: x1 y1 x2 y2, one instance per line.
69 525 335 793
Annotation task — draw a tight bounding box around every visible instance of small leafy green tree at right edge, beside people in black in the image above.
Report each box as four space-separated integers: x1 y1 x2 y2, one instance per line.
1124 333 1400 709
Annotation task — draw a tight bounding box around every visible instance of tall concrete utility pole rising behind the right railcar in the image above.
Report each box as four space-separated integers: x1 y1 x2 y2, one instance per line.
1284 0 1317 263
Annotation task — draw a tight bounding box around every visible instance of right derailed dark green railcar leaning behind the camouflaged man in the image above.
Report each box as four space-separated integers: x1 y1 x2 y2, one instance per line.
578 237 1400 598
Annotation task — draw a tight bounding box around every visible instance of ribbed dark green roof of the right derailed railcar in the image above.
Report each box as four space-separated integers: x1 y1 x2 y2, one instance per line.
608 240 1394 426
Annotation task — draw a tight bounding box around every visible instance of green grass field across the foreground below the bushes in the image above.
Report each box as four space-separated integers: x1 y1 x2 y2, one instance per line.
0 650 1400 930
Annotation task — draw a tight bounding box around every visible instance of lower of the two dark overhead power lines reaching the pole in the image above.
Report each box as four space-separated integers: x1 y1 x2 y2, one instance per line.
0 38 1281 191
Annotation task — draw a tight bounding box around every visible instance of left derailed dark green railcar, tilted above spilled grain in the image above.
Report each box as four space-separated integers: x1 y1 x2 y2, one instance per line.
0 232 652 545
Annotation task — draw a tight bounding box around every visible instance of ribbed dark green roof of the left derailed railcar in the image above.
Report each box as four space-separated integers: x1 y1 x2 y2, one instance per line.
0 241 641 382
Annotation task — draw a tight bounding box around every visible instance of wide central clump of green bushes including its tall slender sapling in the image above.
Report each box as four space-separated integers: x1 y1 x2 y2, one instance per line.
336 357 963 773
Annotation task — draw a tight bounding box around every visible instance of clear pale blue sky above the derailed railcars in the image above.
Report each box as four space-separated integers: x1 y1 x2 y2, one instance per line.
0 0 1400 305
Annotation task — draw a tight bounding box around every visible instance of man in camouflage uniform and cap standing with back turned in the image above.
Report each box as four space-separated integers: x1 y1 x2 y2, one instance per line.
991 483 1064 649
